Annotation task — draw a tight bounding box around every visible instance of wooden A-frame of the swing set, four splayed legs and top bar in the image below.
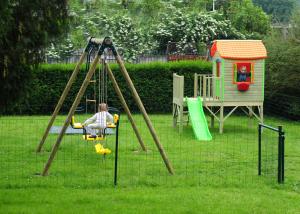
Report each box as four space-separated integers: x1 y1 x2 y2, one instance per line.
37 37 174 176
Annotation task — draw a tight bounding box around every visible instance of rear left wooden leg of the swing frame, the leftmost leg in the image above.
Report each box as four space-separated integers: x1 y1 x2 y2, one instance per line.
36 51 88 152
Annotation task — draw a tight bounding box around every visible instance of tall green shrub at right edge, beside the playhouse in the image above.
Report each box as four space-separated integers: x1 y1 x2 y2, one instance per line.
265 37 300 119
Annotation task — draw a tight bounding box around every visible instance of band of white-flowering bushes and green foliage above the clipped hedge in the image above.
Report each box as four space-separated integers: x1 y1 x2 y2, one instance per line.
47 0 270 62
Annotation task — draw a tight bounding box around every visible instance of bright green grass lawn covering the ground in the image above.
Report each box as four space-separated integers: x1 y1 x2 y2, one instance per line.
0 115 300 213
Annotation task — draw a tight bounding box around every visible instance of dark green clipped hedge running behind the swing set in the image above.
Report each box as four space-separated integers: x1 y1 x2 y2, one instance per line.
1 61 212 114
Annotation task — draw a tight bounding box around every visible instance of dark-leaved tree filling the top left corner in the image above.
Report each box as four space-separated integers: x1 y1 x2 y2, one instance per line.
0 0 68 109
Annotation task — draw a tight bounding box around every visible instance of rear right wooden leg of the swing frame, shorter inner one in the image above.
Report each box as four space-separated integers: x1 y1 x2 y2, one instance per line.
105 63 147 151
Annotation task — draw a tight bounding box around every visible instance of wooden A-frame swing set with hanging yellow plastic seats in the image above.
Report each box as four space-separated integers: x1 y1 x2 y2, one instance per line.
36 37 174 177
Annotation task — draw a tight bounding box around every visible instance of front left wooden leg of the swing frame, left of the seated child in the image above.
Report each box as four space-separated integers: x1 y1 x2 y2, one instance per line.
42 55 100 176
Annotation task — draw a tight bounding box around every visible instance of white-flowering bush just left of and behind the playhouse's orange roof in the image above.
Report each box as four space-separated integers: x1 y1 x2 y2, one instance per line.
152 8 245 52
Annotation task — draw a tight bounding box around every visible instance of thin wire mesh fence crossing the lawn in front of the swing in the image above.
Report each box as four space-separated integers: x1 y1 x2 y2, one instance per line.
0 95 300 188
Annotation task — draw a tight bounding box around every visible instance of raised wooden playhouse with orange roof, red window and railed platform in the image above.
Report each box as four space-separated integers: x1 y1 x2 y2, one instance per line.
173 40 267 133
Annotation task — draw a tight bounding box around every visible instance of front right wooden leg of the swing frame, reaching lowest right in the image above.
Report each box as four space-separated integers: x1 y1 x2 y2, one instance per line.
115 53 174 174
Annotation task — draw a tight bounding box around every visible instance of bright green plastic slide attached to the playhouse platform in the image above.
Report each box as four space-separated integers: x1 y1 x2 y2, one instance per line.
187 97 212 141
